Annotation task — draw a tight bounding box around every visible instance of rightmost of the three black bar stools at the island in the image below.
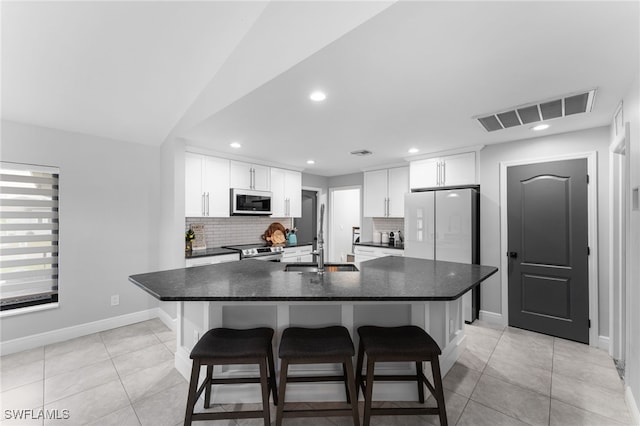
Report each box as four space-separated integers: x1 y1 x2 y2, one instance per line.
356 325 447 426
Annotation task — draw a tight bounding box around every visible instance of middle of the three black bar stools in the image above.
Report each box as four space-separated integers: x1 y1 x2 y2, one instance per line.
276 326 360 426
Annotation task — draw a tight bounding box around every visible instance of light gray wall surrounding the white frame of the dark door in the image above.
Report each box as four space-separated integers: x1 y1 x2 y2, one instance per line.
480 127 610 336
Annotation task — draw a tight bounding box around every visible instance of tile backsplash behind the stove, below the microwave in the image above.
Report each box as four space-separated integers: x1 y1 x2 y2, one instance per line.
185 216 293 247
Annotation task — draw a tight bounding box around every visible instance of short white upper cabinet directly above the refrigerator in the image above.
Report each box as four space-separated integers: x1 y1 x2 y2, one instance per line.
409 152 476 189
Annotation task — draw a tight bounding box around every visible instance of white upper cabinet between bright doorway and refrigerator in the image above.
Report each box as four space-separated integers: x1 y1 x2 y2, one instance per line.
364 167 409 217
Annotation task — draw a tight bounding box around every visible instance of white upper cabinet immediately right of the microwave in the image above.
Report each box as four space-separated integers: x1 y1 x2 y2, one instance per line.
271 167 302 217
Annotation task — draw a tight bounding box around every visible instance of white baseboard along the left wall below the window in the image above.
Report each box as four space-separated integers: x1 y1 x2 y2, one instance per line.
0 308 160 355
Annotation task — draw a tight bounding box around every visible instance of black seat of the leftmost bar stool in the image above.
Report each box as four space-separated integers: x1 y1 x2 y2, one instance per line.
190 327 273 360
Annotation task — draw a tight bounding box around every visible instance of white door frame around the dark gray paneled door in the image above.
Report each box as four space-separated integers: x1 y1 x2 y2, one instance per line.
500 151 609 349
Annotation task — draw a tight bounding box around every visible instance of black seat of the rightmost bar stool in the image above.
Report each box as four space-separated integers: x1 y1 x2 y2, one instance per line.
358 325 442 360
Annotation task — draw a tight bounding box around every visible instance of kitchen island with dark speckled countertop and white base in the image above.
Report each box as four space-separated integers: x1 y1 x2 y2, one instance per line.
129 256 497 402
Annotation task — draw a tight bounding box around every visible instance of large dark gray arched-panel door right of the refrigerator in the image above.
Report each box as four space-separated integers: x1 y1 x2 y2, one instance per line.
507 159 589 343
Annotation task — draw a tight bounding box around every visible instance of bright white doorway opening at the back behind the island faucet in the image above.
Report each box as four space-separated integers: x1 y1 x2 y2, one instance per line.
329 186 362 262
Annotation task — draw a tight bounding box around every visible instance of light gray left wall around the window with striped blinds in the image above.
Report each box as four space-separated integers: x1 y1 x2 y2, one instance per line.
0 121 160 342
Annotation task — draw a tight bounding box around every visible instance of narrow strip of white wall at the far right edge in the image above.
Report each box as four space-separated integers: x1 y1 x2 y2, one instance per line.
623 77 640 422
